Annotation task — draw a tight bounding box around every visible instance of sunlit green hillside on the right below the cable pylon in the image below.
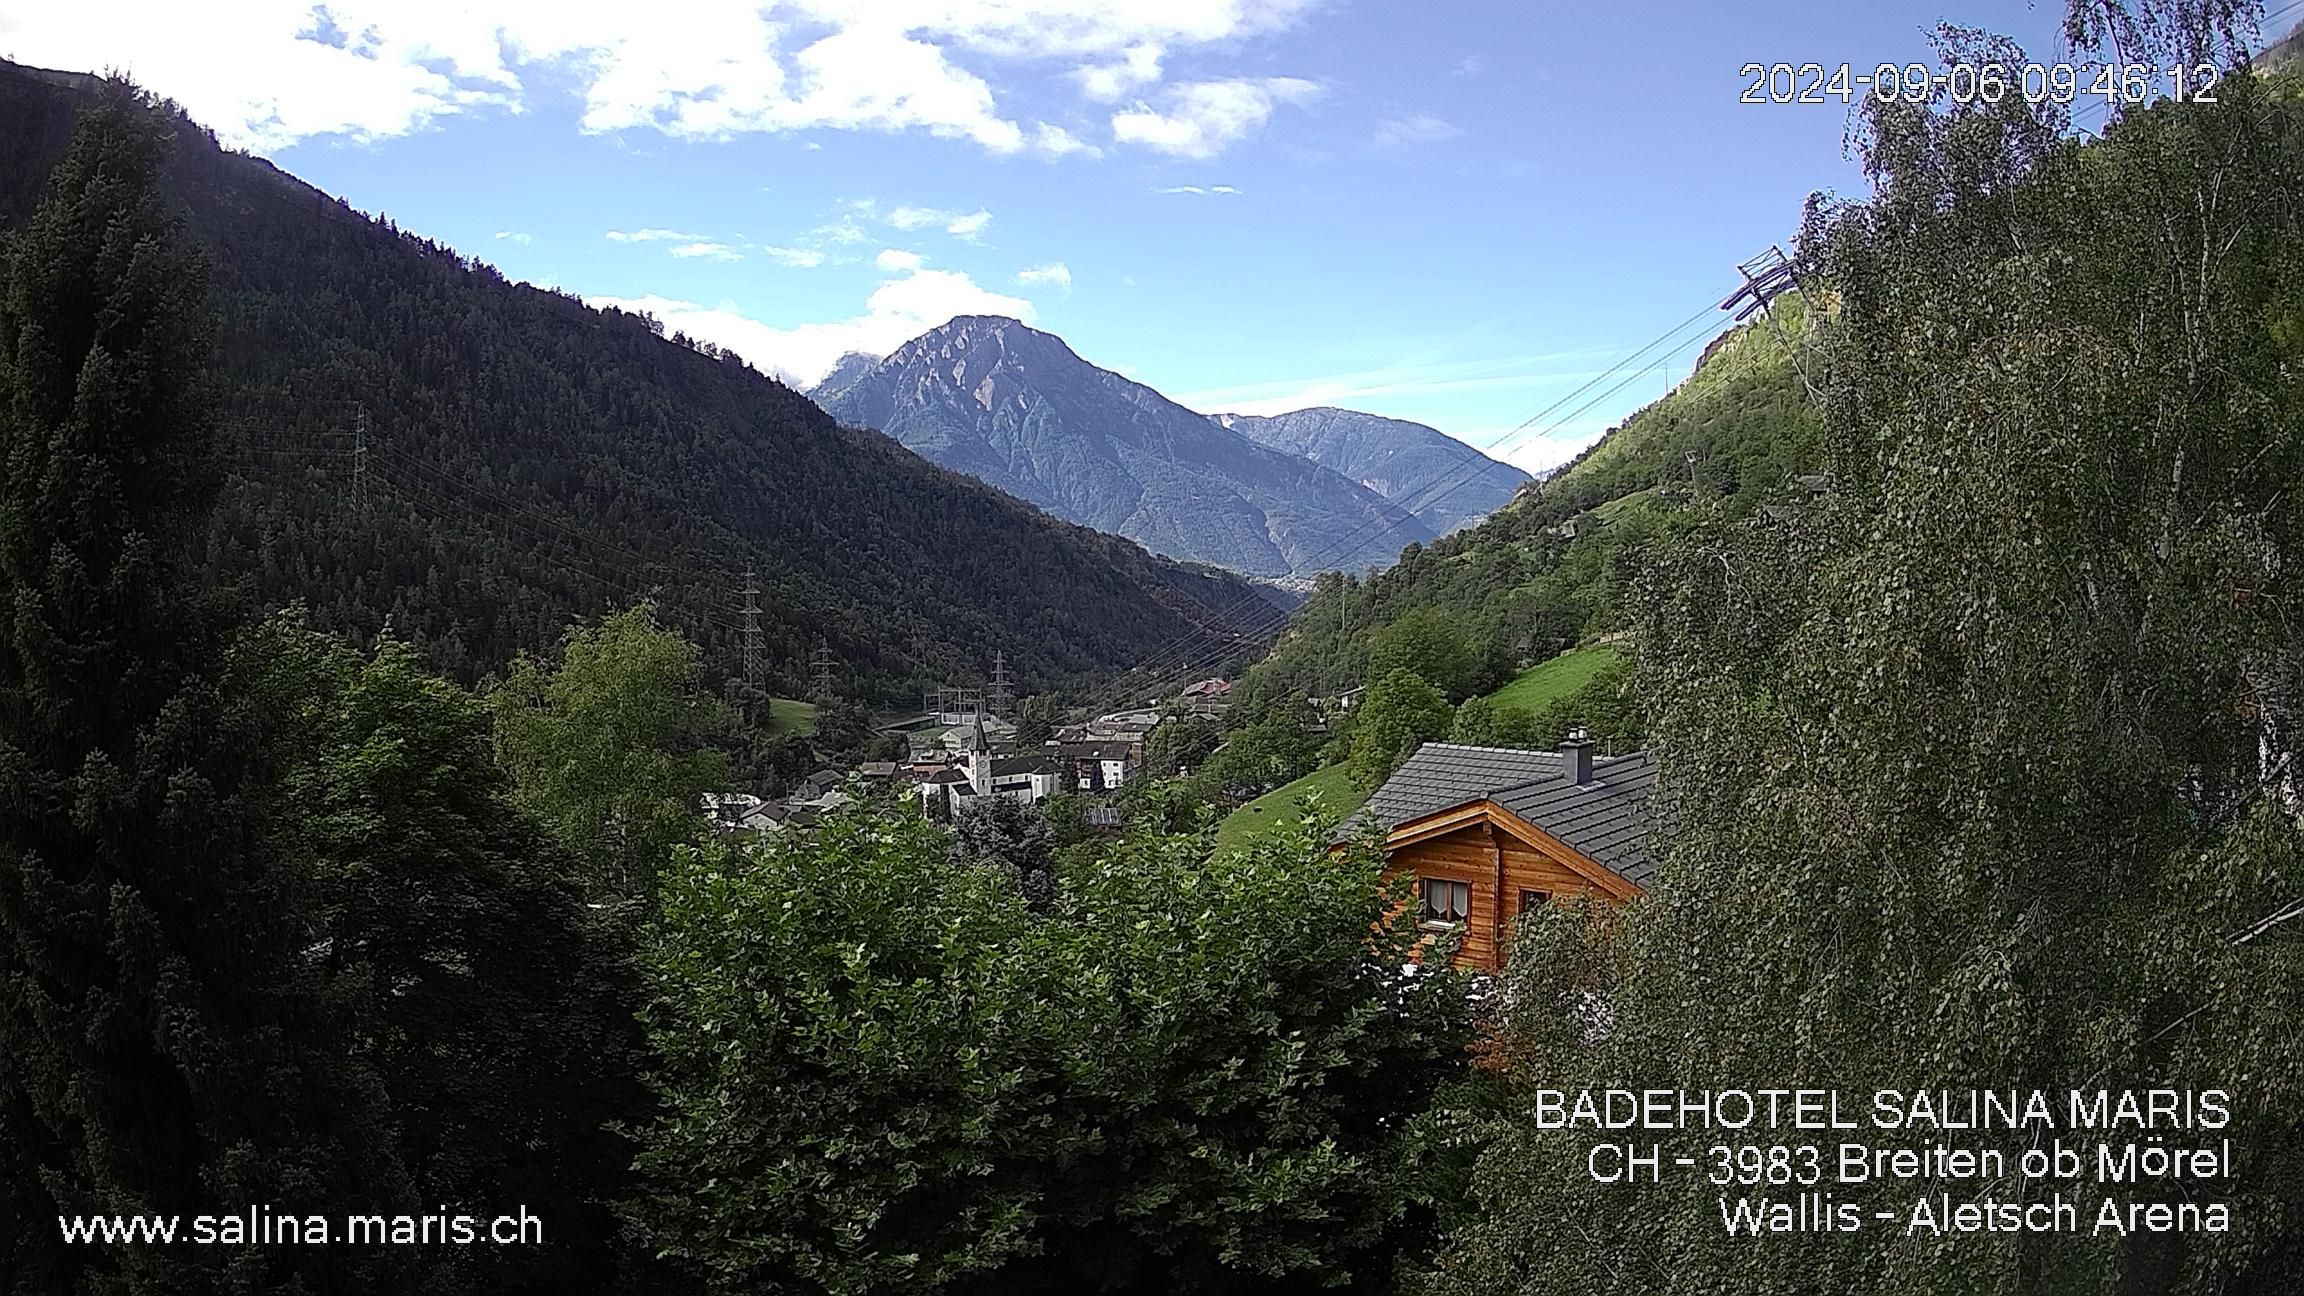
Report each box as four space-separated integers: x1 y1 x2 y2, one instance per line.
1258 297 1818 692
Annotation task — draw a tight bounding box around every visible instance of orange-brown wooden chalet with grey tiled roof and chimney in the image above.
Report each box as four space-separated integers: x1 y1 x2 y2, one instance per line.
1339 731 1657 971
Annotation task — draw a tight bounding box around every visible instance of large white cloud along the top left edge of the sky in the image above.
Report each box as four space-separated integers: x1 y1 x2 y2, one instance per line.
9 0 1320 155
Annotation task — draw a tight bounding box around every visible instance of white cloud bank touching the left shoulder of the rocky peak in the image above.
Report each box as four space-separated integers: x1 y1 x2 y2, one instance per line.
585 255 1032 387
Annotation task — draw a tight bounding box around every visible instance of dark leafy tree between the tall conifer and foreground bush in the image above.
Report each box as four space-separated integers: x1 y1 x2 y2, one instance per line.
230 616 663 1294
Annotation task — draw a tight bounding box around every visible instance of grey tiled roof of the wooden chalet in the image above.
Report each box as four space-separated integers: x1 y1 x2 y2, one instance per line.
1339 743 1657 888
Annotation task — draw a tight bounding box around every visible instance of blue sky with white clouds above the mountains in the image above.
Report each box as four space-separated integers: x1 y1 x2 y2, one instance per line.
0 0 2279 470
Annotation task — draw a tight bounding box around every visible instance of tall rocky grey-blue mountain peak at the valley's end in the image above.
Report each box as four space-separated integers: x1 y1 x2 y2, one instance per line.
811 316 1435 577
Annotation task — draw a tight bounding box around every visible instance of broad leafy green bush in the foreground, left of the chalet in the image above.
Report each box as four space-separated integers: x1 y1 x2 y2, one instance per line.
636 809 1470 1296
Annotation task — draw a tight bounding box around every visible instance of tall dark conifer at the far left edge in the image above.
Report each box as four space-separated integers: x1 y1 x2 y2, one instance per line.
0 83 412 1294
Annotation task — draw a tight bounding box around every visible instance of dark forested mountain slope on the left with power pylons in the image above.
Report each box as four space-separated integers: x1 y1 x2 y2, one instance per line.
0 65 1246 696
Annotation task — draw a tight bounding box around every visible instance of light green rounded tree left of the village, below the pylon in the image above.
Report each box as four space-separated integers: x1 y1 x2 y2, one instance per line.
488 604 730 906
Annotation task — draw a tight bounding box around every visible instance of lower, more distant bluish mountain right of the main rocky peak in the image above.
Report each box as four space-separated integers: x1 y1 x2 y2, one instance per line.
1210 406 1530 535
